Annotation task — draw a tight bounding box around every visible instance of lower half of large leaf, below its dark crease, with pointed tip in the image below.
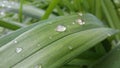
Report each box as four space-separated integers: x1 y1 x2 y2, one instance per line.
13 28 116 68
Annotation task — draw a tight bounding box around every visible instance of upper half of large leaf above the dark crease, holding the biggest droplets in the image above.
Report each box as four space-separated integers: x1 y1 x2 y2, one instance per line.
0 14 103 67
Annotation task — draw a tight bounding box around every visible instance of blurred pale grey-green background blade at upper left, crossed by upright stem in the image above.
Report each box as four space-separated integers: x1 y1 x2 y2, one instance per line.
0 1 44 19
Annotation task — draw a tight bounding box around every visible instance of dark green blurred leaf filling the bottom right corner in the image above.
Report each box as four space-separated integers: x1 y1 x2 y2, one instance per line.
90 45 120 68
